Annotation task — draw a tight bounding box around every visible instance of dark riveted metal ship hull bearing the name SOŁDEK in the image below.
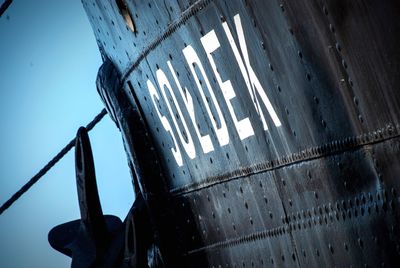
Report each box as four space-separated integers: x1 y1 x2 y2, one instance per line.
83 0 400 267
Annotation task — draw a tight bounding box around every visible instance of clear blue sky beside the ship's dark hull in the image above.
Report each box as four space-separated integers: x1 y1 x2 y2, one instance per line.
0 0 134 268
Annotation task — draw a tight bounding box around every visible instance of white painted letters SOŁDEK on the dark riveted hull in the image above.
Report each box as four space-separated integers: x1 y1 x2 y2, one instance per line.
147 14 281 167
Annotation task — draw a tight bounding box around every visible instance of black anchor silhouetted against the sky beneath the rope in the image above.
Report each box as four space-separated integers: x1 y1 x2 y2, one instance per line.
48 127 123 267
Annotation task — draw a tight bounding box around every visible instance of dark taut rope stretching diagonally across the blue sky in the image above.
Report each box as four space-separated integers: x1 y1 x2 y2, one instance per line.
0 109 107 215
